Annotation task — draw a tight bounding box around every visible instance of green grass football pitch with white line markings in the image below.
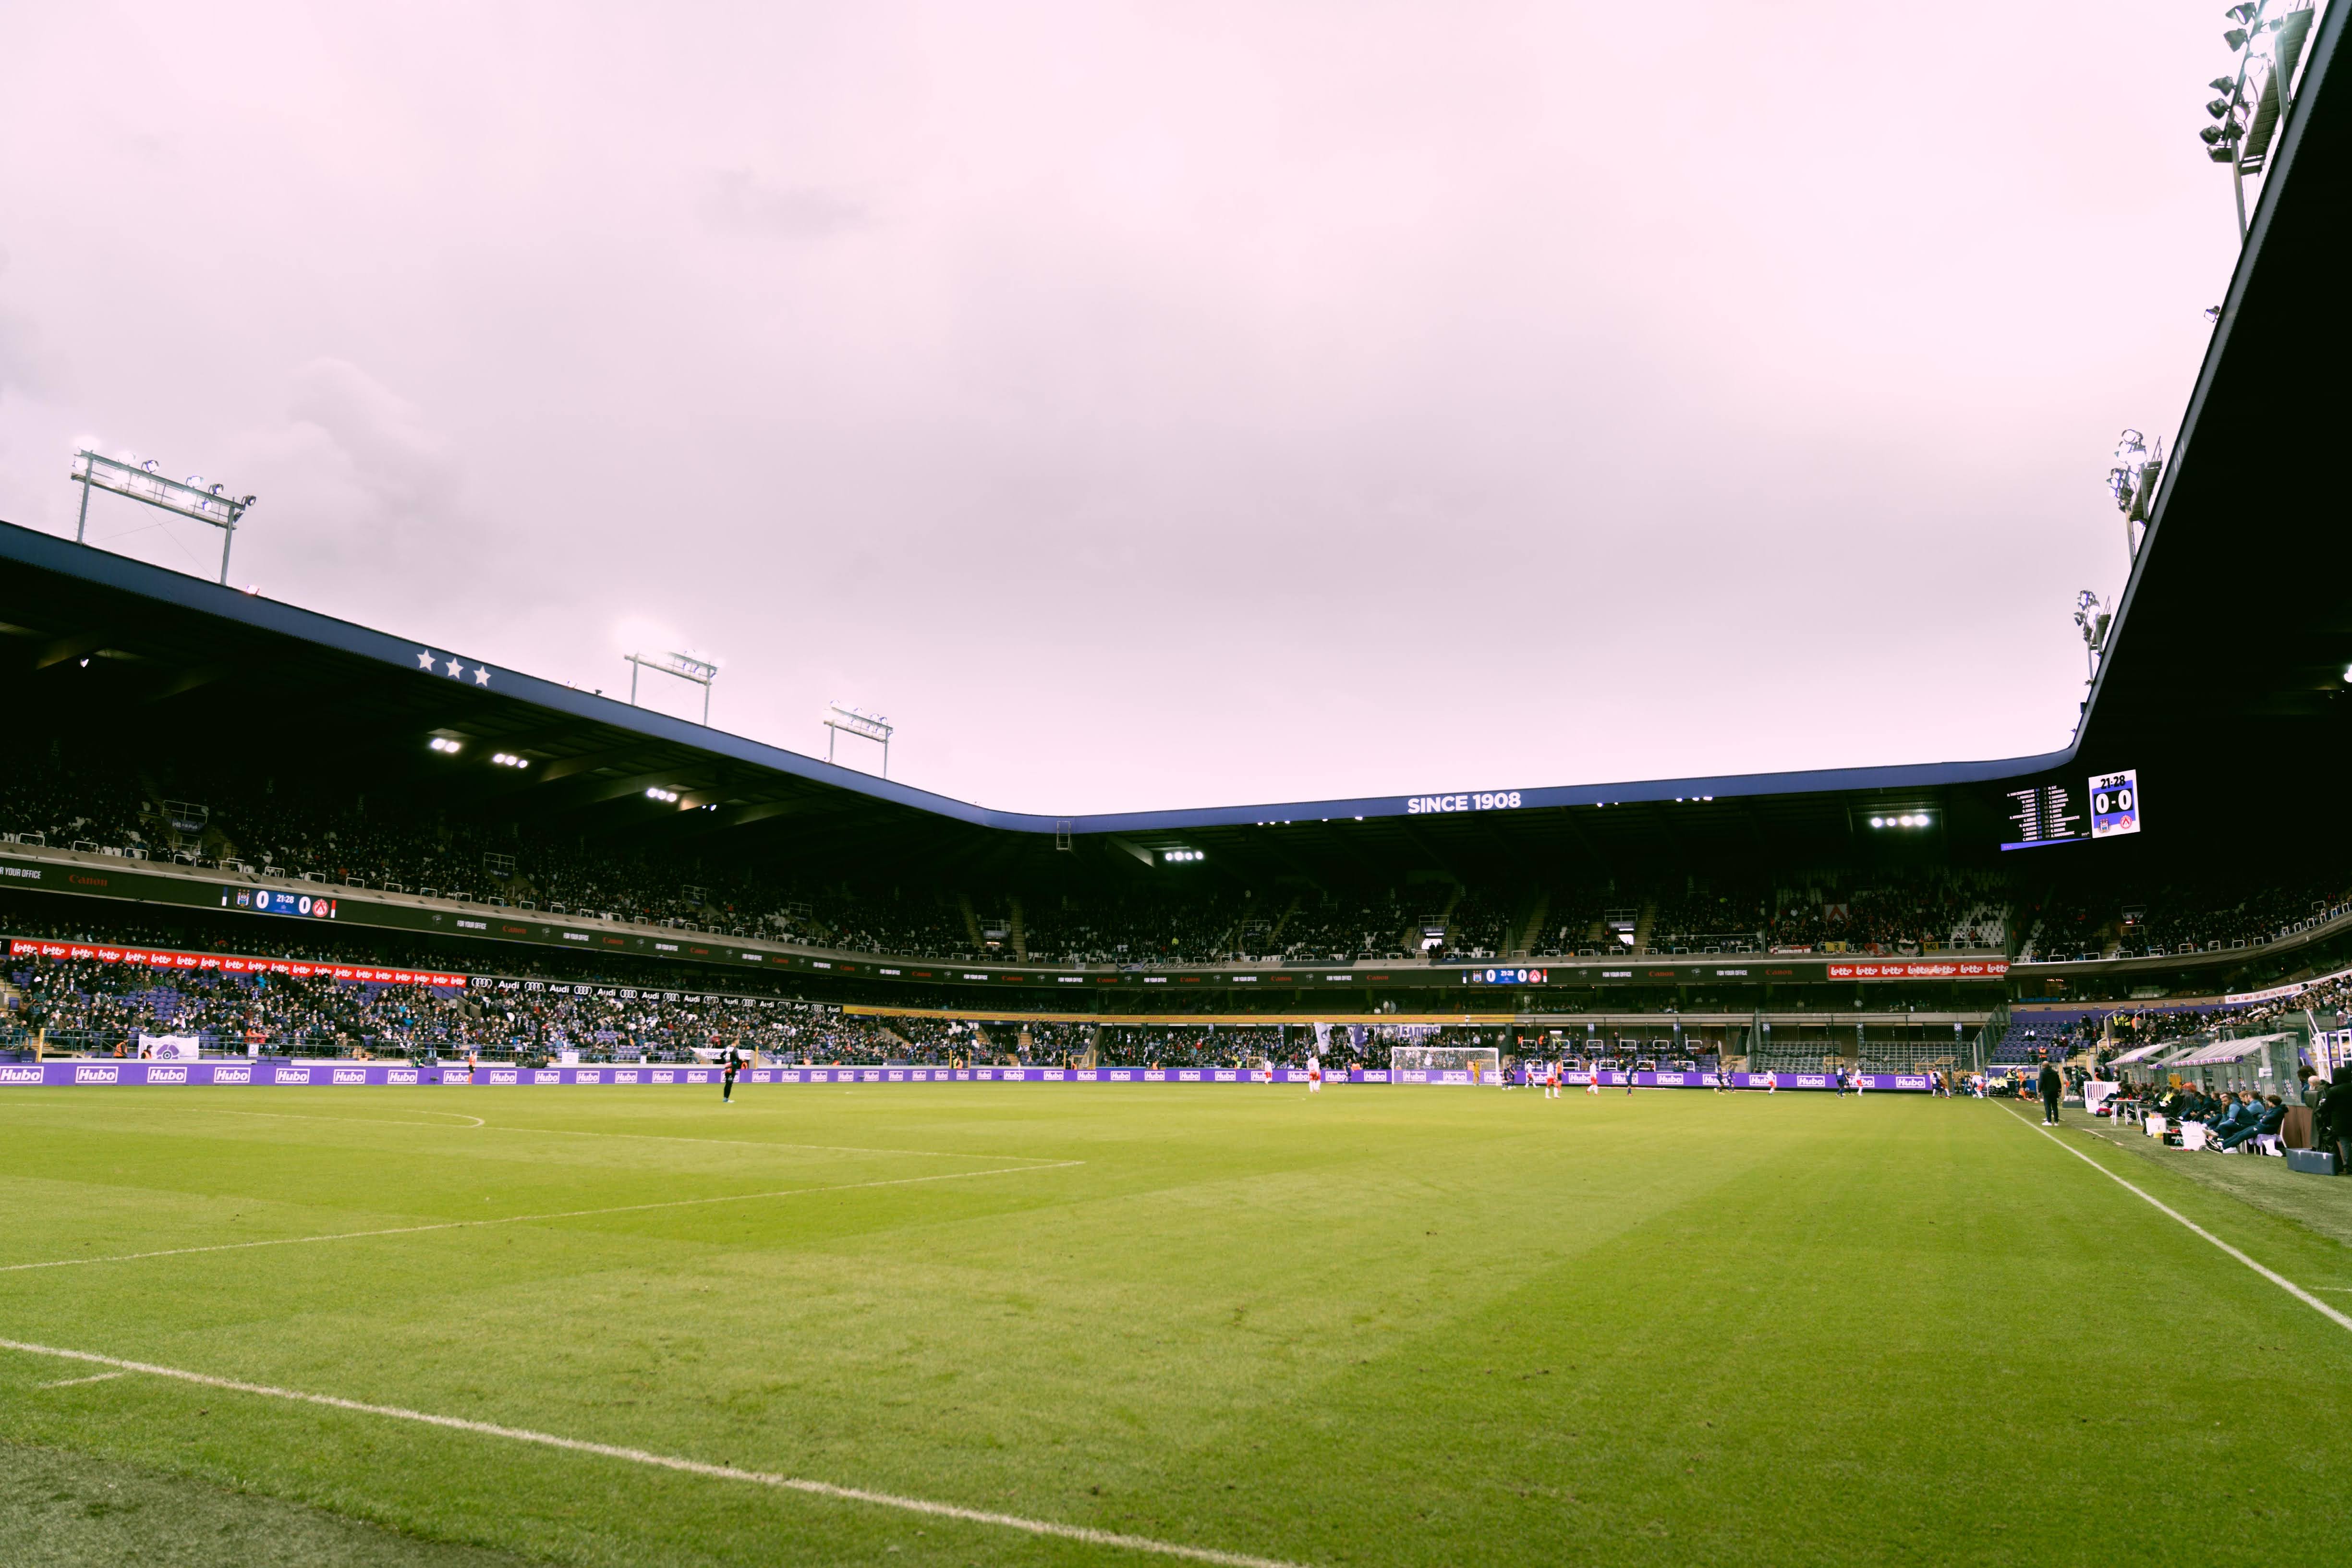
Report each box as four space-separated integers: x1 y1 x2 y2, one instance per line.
0 1084 2352 1568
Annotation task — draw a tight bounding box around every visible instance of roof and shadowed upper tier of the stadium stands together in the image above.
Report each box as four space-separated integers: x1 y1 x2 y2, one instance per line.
0 3 2352 1081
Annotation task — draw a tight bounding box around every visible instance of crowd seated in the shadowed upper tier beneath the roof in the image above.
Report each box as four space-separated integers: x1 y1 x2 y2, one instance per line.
27 743 2347 992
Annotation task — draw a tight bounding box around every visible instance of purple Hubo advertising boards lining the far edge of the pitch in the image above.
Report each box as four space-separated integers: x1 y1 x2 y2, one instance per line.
0 1058 1926 1093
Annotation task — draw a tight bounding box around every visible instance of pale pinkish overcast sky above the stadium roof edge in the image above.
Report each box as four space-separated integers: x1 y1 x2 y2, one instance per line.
0 0 2237 814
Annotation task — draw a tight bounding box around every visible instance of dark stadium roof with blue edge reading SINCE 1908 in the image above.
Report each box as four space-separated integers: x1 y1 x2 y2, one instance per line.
0 7 2352 879
